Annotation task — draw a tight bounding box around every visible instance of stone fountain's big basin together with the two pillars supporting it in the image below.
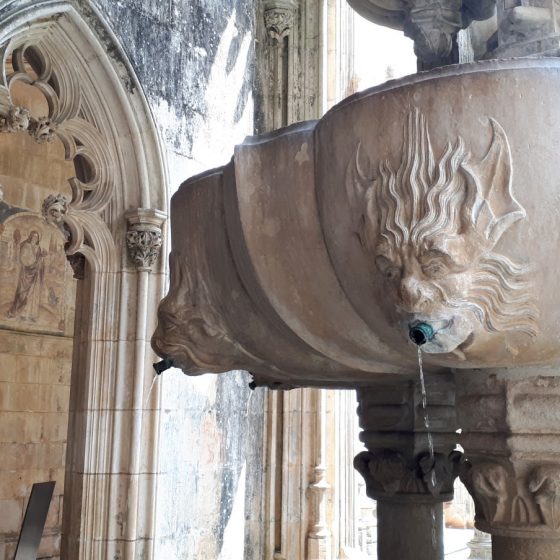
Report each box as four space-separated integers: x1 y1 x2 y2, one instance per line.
153 5 560 560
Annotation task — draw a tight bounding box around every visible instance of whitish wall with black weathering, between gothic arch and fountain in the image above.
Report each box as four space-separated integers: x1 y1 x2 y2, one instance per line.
91 0 264 560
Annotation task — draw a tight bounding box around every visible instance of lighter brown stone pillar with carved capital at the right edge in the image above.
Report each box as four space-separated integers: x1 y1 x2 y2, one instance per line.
456 370 560 560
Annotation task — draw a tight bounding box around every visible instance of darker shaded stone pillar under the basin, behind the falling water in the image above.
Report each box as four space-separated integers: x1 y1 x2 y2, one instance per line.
354 376 462 560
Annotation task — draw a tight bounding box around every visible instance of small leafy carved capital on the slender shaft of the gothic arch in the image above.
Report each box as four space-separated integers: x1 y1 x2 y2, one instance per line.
126 208 167 271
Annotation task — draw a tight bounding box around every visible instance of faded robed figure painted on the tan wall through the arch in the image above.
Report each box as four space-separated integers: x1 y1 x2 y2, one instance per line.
8 230 47 321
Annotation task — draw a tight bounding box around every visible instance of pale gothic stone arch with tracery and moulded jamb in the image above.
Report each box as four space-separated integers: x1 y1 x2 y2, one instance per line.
0 0 168 559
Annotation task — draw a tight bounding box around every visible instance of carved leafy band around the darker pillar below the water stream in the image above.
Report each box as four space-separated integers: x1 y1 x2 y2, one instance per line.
354 449 462 501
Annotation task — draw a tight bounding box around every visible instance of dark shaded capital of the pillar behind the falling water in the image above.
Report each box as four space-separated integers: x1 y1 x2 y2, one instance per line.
354 376 462 502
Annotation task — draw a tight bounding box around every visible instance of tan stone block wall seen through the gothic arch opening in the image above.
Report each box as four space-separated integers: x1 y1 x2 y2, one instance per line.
0 76 76 560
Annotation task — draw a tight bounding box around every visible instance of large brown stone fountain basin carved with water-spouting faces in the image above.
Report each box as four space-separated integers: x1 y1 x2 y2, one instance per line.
153 59 560 387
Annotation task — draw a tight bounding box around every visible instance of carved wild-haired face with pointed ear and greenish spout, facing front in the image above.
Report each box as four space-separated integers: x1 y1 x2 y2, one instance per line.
348 110 537 354
